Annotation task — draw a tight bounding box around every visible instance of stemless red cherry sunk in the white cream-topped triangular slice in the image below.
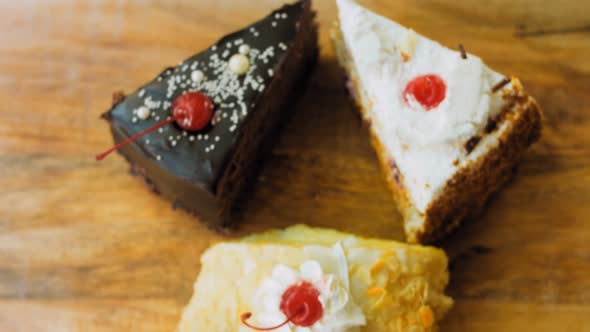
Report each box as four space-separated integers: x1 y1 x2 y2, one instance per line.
403 74 447 111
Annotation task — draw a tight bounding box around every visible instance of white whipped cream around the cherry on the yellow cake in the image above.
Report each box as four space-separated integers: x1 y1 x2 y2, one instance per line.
252 243 366 332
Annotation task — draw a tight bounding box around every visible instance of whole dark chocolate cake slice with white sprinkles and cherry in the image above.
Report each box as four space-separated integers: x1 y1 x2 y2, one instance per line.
97 0 318 228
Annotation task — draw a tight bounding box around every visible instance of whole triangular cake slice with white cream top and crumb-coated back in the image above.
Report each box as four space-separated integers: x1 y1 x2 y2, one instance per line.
332 0 542 242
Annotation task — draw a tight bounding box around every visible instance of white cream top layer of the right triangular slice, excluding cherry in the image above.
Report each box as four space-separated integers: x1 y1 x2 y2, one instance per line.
337 0 503 212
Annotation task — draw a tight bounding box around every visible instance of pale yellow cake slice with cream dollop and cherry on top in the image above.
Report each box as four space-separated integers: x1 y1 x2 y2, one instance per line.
177 225 453 332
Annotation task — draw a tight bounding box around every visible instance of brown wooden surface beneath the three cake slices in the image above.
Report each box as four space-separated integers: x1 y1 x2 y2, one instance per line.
0 0 590 331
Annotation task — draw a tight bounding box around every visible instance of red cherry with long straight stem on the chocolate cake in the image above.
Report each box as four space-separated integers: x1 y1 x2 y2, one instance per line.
96 92 213 160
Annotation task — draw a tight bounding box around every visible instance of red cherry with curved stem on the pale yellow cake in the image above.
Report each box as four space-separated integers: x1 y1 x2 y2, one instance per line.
240 281 324 331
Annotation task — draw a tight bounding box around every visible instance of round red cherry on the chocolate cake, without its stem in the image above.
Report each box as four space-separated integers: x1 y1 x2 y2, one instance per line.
172 92 213 131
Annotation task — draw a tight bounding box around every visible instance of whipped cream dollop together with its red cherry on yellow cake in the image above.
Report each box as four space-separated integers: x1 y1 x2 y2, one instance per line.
240 250 365 332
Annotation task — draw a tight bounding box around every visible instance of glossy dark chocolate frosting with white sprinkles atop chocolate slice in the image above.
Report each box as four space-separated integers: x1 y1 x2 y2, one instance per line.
105 1 306 195
